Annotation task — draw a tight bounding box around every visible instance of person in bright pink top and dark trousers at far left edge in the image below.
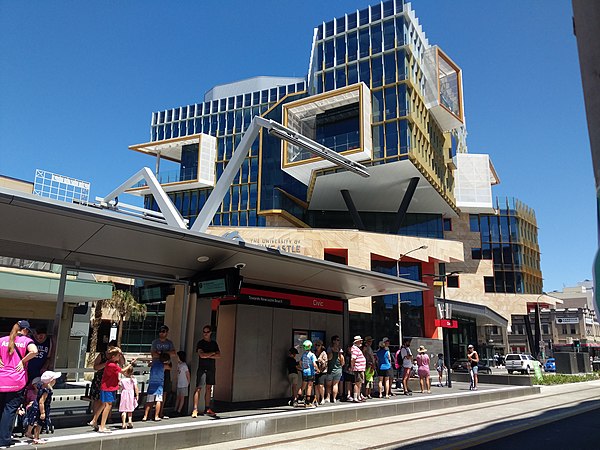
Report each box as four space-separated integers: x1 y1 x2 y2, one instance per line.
0 320 37 446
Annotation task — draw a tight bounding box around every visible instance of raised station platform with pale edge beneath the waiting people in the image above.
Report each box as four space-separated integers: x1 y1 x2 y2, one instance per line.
5 382 540 450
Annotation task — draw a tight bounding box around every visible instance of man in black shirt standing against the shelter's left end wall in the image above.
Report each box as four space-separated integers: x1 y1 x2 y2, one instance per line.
192 325 221 417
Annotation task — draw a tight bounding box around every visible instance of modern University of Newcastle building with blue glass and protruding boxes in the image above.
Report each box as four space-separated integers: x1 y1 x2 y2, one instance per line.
124 0 554 357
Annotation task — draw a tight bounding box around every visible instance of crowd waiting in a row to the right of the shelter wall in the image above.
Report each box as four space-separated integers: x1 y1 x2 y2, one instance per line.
286 335 446 408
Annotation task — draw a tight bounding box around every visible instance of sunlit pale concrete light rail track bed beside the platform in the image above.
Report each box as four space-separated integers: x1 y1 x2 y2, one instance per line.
190 381 600 450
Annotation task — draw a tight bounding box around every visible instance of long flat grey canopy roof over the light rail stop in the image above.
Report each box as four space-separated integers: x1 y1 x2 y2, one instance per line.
0 189 428 299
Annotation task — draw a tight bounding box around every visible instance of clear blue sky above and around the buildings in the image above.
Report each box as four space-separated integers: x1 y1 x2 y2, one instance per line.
0 0 597 291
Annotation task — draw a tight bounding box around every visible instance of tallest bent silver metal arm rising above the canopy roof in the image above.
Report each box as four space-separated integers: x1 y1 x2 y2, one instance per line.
191 116 369 232
